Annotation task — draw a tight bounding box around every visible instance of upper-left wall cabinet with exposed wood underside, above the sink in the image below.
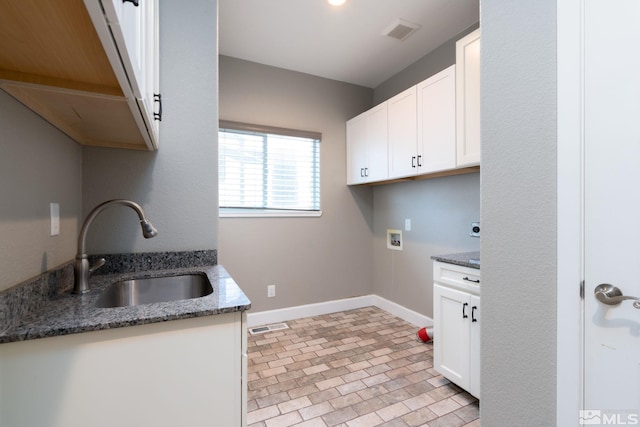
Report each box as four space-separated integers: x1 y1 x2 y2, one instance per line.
0 0 159 150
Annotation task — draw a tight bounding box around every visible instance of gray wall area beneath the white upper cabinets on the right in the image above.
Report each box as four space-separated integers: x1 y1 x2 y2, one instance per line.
373 173 480 317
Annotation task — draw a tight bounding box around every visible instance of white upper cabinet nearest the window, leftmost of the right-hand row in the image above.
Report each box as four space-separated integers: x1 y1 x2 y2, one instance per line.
347 103 389 185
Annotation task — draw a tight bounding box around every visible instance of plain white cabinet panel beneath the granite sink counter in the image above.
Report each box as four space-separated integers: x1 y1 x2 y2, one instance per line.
0 312 246 427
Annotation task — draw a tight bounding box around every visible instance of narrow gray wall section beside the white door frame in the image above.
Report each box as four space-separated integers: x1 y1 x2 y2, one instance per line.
481 0 556 426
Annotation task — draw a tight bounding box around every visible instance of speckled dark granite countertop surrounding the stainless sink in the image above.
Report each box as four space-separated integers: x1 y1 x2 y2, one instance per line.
0 252 251 344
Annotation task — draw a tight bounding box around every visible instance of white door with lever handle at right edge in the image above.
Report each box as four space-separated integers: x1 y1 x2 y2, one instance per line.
581 0 640 425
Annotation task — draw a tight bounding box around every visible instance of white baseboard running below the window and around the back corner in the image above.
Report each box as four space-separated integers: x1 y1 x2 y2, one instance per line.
247 295 433 328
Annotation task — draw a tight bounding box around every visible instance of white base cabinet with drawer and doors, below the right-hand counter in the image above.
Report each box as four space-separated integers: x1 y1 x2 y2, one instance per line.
433 262 480 398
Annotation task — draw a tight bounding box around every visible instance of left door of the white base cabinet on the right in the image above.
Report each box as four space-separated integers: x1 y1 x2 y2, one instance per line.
433 283 471 390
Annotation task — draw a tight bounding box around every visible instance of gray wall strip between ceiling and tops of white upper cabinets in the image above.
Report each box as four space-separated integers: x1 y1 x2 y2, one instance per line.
373 23 479 105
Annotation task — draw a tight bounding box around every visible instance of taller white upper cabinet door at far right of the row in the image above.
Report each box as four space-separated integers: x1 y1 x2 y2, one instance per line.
456 29 480 167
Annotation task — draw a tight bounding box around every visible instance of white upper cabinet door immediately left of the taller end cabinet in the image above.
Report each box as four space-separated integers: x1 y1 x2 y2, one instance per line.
417 65 456 174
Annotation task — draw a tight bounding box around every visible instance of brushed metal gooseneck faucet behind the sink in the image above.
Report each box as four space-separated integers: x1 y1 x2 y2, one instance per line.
73 199 158 294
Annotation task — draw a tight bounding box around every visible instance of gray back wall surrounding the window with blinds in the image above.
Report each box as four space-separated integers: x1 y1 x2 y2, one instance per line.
218 56 373 311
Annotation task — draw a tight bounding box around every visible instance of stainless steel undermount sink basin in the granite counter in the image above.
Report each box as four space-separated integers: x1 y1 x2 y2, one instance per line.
96 274 213 308
